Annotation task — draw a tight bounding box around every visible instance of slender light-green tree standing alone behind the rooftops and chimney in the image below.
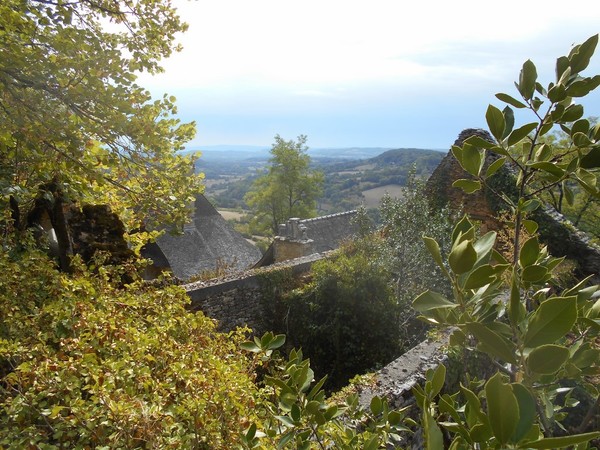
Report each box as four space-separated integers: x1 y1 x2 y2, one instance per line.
245 135 323 234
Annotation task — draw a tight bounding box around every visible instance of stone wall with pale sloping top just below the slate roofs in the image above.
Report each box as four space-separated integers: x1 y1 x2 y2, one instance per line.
184 252 328 335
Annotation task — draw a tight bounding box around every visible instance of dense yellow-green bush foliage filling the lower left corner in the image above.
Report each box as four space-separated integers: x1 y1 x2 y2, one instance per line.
0 250 257 449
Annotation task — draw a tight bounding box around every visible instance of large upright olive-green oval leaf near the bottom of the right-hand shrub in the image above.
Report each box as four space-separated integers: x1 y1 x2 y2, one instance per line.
485 372 519 445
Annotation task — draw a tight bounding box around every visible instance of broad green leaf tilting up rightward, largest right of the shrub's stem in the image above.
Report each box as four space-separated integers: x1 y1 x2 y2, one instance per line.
524 296 577 348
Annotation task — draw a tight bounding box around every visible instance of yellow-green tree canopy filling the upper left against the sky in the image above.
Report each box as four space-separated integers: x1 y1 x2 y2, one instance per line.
0 0 201 246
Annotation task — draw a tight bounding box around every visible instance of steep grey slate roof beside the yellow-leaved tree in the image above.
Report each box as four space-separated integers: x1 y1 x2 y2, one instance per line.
142 195 261 280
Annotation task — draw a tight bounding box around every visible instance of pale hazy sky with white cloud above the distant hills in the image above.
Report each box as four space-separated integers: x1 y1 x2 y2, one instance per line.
139 0 600 149
